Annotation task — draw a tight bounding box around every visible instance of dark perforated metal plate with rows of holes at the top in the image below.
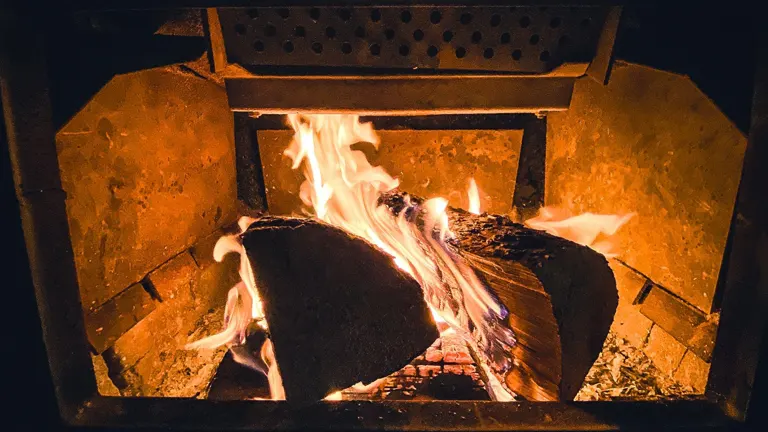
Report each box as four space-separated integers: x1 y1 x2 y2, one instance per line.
219 6 606 73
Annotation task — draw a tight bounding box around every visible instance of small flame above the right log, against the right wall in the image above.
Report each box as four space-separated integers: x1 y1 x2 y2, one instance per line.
525 207 635 258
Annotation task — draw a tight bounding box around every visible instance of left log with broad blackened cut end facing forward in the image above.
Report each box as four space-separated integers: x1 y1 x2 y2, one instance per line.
242 217 439 404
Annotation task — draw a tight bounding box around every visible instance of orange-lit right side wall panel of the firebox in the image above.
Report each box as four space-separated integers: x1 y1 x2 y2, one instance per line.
545 62 746 312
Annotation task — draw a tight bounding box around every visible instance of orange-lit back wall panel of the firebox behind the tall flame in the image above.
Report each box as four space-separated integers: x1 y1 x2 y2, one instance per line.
258 130 523 215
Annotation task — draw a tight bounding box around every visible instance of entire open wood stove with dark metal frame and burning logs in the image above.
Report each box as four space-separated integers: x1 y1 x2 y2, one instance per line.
2 2 765 429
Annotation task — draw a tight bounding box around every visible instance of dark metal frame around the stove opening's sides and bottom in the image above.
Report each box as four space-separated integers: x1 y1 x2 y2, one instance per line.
0 2 768 430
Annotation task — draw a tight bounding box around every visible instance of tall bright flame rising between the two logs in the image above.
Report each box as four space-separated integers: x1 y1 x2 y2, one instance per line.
285 114 515 400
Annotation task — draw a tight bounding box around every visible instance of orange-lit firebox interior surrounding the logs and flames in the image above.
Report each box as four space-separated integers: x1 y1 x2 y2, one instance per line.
51 8 745 399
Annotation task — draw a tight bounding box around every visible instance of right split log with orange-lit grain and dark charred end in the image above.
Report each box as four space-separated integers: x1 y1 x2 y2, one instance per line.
382 193 618 401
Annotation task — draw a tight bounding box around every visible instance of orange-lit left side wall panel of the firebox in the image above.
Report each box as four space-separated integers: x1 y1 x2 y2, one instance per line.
56 68 237 310
